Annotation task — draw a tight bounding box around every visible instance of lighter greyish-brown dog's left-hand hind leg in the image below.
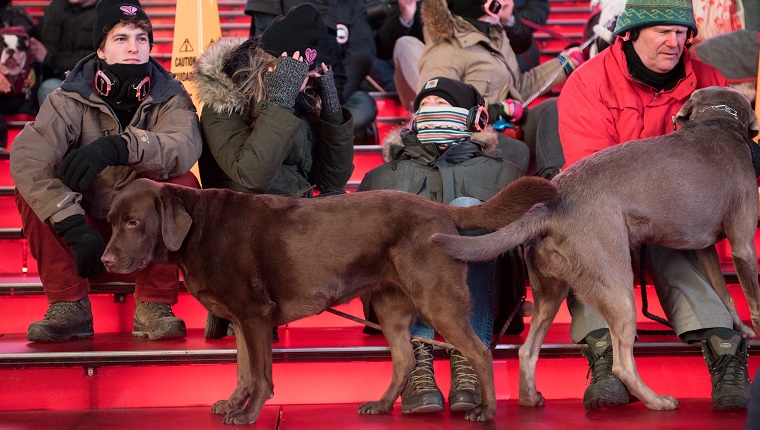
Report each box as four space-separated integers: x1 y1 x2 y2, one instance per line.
519 245 568 406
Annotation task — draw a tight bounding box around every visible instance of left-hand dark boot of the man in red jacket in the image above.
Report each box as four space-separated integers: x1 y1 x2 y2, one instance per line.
581 330 635 410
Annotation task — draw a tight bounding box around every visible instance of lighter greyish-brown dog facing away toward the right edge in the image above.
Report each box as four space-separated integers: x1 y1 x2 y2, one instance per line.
433 87 760 410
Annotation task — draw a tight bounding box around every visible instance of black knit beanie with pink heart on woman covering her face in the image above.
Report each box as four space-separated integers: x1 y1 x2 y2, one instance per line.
259 4 327 66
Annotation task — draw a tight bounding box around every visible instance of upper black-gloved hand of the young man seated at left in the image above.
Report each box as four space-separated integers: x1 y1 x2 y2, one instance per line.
57 136 129 191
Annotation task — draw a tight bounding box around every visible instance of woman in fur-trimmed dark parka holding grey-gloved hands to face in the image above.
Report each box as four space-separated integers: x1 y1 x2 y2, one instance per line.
195 5 353 197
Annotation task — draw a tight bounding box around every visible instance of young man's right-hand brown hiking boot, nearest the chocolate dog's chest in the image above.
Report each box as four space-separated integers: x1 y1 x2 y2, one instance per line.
132 299 187 340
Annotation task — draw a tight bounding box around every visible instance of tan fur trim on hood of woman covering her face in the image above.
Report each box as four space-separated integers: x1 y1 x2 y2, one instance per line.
193 37 248 115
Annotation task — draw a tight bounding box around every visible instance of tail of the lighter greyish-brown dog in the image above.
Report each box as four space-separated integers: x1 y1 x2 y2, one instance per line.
431 183 551 261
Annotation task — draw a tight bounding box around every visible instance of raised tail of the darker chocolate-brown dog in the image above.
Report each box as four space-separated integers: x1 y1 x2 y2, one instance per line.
448 176 557 230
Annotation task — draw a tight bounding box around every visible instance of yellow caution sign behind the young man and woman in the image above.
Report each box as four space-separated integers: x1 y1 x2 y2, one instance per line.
171 0 222 180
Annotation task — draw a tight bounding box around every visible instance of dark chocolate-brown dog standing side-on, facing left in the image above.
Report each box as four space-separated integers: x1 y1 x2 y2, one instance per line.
102 178 556 424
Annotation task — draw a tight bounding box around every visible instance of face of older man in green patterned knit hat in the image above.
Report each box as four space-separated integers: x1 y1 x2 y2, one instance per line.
633 25 689 73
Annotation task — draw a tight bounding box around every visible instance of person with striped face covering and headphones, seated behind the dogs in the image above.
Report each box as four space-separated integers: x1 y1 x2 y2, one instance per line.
359 77 527 413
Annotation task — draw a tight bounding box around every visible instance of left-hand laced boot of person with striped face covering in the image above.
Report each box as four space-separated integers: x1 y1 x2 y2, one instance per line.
401 340 443 414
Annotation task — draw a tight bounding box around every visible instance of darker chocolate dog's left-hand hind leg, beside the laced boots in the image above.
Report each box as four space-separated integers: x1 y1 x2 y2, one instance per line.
358 289 415 414
